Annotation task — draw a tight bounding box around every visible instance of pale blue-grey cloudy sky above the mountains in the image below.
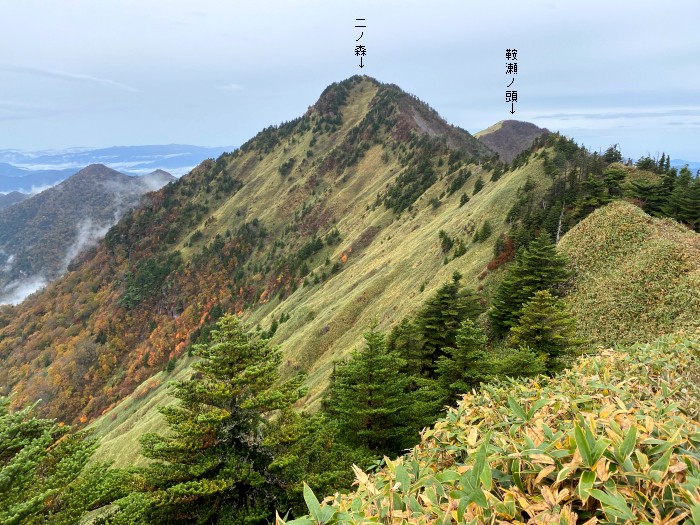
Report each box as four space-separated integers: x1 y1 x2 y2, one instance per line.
0 0 700 161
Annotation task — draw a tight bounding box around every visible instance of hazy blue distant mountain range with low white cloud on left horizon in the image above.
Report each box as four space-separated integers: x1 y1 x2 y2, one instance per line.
0 144 234 193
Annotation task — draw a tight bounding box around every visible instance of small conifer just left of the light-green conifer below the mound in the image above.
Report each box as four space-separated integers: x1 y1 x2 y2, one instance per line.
436 319 491 405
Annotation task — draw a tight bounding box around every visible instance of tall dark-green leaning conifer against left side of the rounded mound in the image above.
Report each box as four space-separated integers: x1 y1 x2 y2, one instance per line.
488 234 568 336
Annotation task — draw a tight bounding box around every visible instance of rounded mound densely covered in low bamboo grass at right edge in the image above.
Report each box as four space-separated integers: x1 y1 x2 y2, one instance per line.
559 202 700 344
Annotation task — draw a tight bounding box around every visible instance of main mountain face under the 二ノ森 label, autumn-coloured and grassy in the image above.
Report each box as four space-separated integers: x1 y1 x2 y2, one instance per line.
0 77 508 421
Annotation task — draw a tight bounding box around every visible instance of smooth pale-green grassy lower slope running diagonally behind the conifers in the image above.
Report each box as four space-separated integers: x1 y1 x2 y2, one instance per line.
89 155 546 466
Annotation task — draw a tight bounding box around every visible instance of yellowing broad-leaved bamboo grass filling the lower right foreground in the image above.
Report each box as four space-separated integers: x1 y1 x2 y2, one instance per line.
288 333 700 524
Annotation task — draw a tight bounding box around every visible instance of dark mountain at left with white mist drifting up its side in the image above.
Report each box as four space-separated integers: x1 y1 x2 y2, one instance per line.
0 164 176 304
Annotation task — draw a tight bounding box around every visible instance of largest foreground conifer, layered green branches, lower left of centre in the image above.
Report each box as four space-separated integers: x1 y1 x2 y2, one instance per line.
115 315 301 523
